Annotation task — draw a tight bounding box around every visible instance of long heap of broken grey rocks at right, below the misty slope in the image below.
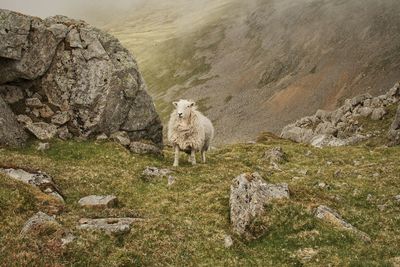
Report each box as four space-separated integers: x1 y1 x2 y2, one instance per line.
281 83 400 147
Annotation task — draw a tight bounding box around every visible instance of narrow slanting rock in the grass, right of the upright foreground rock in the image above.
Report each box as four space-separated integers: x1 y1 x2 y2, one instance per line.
315 205 371 242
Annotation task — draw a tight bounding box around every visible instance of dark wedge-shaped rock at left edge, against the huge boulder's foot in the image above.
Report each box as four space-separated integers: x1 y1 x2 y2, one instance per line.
0 97 28 147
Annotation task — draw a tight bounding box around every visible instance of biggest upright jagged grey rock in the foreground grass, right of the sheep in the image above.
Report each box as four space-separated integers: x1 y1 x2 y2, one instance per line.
229 173 289 235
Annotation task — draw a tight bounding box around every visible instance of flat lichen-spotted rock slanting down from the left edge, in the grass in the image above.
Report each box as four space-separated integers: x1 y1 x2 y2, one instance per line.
0 168 64 202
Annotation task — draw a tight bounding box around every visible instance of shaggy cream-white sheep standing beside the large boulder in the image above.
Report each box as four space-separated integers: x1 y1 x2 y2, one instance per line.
168 99 214 167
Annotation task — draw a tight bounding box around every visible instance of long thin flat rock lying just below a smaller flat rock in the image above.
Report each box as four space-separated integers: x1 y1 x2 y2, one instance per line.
78 218 142 235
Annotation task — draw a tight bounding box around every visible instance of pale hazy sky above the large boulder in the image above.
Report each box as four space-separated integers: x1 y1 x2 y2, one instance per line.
0 0 148 24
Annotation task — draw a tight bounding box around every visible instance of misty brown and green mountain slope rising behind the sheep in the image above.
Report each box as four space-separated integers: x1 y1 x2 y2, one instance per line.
104 0 400 146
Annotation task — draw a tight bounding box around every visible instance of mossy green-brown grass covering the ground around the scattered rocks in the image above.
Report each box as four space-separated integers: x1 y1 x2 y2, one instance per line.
0 135 400 266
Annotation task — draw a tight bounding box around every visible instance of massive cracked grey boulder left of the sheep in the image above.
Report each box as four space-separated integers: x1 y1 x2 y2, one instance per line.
0 9 162 147
